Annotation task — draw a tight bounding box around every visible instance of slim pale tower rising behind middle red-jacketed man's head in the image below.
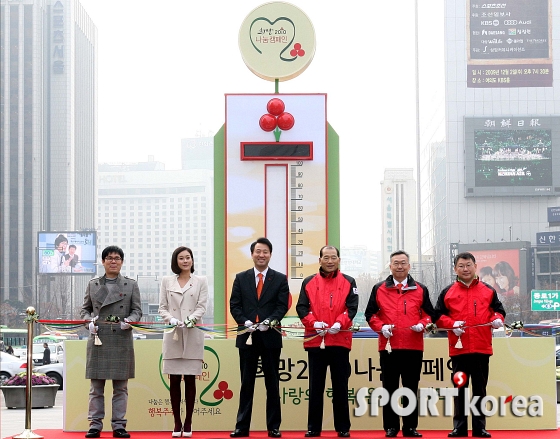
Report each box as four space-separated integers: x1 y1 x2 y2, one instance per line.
381 169 418 268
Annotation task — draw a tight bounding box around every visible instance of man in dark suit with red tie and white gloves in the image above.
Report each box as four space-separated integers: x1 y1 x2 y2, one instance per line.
229 238 290 437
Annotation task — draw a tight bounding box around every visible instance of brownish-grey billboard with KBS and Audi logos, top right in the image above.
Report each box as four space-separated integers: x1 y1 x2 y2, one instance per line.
467 0 552 88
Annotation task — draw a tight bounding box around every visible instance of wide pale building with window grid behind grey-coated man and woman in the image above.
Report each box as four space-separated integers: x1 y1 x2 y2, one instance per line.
97 161 214 321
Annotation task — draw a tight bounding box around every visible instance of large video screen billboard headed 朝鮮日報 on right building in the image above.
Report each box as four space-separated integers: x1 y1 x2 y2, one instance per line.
465 116 560 197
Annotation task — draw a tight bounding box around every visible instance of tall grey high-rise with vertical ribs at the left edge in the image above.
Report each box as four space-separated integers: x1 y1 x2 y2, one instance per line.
0 0 97 313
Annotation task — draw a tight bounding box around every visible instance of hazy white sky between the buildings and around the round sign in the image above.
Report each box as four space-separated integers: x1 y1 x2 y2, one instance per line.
81 0 439 250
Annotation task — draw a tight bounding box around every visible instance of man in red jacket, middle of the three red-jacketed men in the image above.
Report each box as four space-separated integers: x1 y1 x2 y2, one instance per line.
365 250 434 437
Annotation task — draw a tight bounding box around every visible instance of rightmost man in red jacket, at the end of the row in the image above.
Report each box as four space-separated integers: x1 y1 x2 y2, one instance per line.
436 252 506 438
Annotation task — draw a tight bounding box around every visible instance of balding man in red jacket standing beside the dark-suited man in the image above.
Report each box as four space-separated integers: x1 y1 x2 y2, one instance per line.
296 245 359 437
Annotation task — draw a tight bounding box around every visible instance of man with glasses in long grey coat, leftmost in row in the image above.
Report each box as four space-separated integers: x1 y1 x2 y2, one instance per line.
80 245 142 438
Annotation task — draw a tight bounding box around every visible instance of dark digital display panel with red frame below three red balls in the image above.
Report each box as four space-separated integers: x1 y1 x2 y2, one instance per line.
241 142 313 160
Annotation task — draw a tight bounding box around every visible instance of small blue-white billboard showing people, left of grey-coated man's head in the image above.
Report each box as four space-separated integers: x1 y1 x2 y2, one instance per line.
37 231 97 276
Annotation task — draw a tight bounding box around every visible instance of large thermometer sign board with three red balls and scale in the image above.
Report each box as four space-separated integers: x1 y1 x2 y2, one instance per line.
216 94 339 324
